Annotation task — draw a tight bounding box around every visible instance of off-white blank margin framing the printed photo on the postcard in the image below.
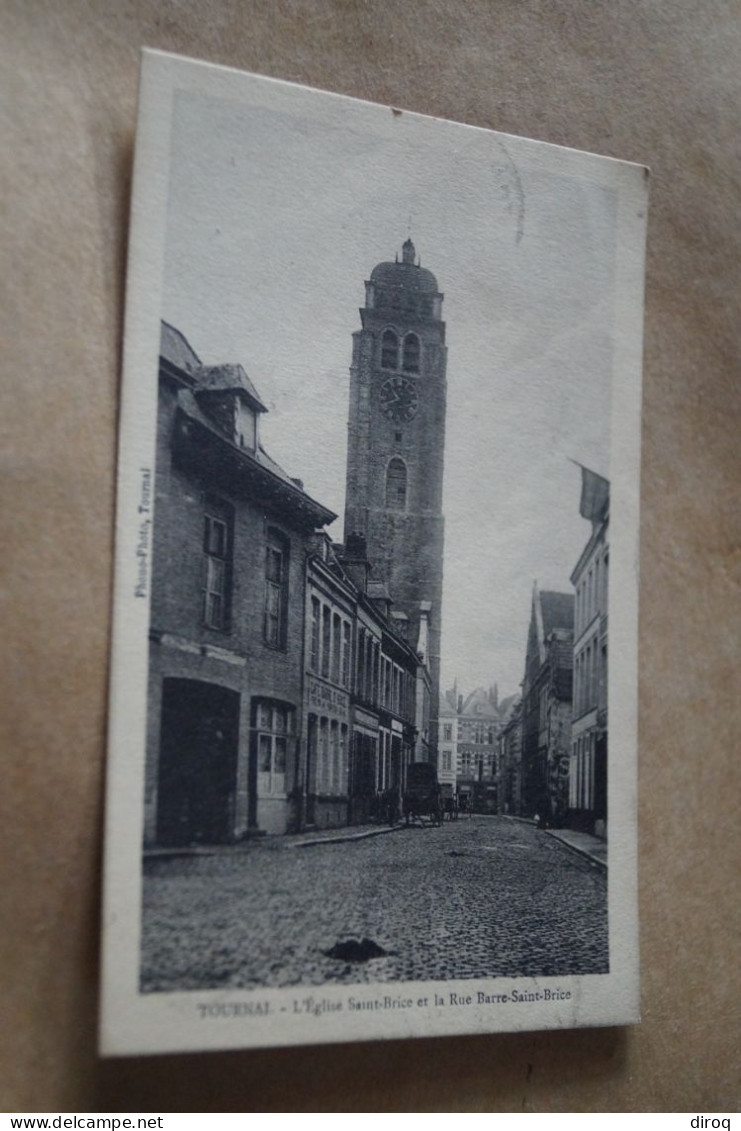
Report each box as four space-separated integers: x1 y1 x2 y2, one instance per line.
101 51 647 1055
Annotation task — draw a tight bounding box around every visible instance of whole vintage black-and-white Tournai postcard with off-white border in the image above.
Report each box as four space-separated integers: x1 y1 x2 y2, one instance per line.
101 44 647 1054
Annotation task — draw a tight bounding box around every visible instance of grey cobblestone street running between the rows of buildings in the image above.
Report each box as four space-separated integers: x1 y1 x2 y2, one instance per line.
141 817 608 991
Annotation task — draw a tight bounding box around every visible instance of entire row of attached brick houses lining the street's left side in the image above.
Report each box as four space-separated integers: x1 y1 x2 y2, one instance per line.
145 303 441 846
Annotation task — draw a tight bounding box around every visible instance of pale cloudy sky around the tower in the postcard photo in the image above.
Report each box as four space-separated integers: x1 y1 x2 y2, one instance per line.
162 93 617 696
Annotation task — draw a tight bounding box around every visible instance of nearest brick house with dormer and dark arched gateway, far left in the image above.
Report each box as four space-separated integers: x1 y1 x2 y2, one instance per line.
145 323 335 845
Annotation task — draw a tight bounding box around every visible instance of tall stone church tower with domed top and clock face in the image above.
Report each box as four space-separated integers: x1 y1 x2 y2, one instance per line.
345 240 447 746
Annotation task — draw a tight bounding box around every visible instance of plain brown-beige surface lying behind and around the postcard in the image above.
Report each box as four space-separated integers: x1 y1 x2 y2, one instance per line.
0 0 741 1113
